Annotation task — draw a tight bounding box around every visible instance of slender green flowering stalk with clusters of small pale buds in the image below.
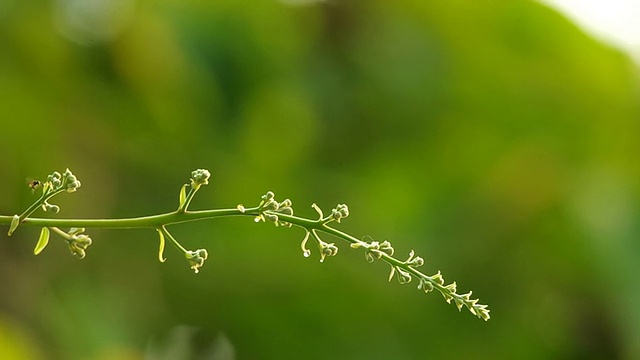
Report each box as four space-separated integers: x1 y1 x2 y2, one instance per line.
0 169 490 320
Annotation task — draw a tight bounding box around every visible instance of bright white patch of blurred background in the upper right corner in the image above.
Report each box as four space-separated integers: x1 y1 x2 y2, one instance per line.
539 0 640 62
